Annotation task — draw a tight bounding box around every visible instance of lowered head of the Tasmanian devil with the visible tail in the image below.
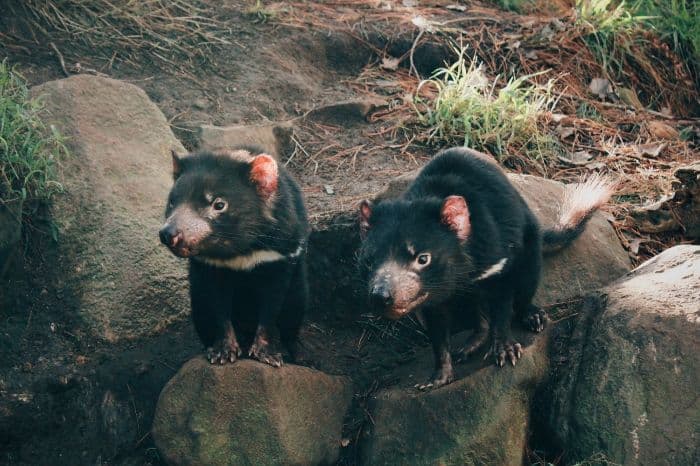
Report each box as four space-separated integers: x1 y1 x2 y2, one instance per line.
360 196 471 319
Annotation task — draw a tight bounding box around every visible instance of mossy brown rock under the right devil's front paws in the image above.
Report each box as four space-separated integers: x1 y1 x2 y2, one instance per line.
362 337 547 466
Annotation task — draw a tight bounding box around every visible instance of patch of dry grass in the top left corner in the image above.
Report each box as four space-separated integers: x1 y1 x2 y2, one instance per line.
7 0 231 69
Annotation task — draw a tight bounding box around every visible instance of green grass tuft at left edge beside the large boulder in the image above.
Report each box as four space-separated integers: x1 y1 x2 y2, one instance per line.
0 60 66 220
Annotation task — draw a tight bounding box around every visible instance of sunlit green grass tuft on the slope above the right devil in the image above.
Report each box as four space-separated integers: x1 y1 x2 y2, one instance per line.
416 48 557 159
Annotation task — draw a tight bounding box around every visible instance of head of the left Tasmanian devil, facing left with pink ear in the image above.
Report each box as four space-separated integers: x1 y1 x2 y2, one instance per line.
160 149 278 258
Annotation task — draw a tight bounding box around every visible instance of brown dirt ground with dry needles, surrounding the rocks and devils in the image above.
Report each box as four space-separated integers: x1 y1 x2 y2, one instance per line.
0 0 700 465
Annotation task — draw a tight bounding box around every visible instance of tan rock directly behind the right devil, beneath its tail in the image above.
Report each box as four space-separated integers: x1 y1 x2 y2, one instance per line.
377 171 630 305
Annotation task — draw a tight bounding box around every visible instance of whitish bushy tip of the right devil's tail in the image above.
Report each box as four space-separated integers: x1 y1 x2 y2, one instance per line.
556 174 615 229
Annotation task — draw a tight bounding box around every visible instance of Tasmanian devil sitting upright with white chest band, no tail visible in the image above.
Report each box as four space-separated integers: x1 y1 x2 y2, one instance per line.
160 148 309 366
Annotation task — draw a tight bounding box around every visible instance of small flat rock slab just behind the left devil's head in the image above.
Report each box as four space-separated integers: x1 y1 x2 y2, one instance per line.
199 123 294 160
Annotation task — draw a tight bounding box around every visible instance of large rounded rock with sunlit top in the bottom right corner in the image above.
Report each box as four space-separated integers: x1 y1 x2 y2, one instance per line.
545 246 700 466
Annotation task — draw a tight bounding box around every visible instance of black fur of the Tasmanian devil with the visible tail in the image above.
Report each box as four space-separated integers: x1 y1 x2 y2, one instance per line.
360 148 596 388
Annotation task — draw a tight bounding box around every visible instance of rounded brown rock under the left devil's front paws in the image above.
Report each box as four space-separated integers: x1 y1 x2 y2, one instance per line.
152 357 352 466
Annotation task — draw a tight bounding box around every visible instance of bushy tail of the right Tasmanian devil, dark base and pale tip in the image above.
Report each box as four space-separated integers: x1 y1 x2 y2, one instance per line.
543 175 615 253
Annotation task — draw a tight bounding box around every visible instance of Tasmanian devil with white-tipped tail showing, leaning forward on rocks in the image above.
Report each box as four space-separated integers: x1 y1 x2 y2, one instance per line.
359 148 613 389
